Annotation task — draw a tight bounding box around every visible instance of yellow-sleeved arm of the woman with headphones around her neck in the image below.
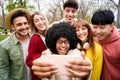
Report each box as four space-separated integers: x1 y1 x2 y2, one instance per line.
91 42 103 80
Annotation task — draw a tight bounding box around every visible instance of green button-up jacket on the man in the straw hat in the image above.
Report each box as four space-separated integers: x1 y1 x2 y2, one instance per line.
0 34 27 80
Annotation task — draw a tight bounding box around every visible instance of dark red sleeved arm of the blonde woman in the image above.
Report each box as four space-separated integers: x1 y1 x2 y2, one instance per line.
26 35 46 67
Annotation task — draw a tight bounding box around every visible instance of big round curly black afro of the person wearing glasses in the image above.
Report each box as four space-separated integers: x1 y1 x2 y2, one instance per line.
45 22 77 54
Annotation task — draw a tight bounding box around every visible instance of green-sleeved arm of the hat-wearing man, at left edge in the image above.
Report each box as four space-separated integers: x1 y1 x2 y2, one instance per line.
0 44 9 80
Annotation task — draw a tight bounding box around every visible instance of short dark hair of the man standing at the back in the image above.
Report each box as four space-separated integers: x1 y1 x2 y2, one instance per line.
63 0 78 10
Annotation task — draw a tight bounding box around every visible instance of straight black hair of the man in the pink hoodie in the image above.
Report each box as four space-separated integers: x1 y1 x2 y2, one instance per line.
91 10 114 25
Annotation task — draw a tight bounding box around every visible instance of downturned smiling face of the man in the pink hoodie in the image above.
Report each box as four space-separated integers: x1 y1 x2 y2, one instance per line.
92 24 113 41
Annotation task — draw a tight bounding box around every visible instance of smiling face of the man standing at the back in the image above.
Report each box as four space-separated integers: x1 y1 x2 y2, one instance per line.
63 7 77 24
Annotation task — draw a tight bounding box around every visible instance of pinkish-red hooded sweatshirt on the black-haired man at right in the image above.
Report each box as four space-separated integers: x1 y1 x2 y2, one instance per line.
96 27 120 80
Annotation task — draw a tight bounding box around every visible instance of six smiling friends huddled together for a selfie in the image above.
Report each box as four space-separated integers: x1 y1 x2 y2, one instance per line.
0 0 120 80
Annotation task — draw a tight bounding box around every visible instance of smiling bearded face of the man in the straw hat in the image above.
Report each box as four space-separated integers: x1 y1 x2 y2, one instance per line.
12 16 29 37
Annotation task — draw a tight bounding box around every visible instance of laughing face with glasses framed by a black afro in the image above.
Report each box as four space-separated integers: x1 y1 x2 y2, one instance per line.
56 37 70 55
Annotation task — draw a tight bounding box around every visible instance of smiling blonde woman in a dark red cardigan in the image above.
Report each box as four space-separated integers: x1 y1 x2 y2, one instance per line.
26 12 48 80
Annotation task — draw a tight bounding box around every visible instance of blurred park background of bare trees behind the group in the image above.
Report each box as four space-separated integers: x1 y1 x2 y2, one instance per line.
0 0 120 41
